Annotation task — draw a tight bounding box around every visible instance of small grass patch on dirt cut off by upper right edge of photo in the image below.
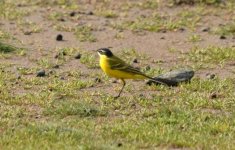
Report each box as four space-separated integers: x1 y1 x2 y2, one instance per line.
214 23 235 36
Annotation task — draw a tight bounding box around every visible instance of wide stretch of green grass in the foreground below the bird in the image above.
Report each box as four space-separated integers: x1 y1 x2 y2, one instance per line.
0 67 235 149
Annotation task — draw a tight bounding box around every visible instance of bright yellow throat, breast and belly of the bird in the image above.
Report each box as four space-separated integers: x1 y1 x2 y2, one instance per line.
100 55 146 79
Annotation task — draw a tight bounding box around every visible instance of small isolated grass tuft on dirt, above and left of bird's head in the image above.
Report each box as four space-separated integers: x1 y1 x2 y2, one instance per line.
74 26 97 42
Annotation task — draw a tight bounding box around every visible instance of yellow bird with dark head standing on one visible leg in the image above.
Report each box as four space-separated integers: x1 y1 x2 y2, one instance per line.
96 48 164 98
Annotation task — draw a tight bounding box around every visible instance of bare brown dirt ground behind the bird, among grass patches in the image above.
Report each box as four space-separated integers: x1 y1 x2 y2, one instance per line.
0 0 235 85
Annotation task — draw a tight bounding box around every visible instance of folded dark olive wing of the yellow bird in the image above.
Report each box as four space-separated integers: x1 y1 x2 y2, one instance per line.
109 56 146 76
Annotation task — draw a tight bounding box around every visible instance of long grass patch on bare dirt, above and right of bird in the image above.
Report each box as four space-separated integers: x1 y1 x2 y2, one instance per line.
112 12 200 32
